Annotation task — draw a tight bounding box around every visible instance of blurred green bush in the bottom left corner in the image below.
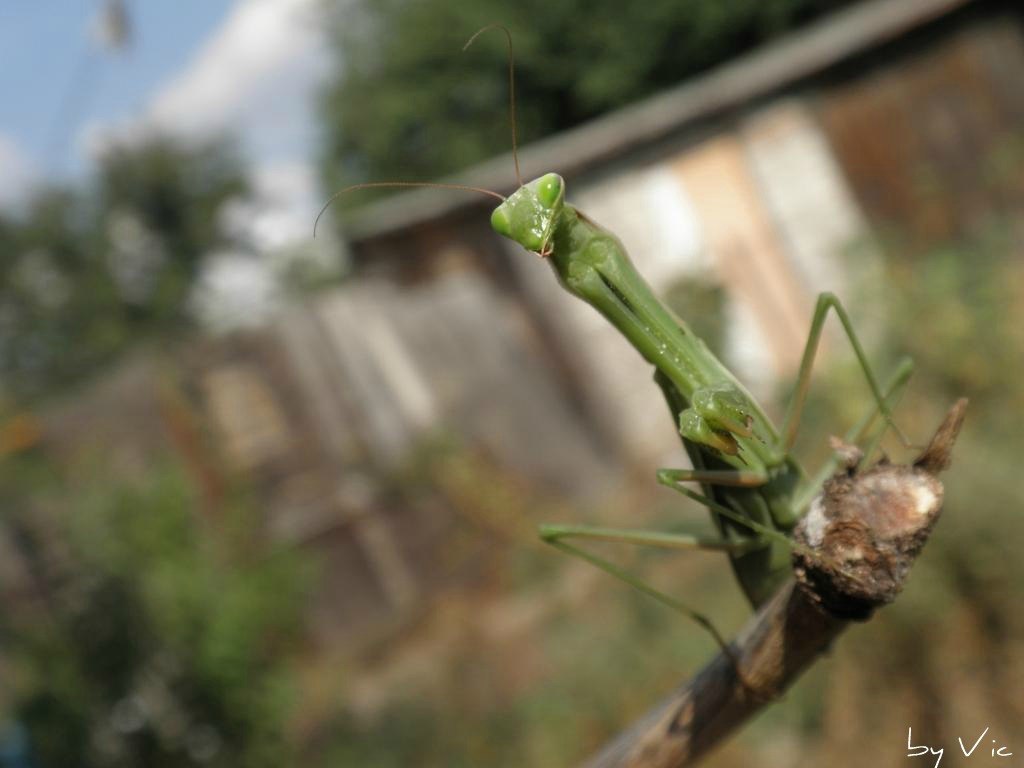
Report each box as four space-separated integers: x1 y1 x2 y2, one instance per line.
0 465 305 768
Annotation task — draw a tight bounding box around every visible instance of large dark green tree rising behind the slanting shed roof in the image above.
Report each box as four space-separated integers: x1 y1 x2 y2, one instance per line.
323 0 849 187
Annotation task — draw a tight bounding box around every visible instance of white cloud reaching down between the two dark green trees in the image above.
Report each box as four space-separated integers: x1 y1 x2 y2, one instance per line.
83 0 339 329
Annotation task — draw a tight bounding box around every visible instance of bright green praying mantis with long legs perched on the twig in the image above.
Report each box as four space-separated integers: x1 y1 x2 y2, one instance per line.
314 25 912 648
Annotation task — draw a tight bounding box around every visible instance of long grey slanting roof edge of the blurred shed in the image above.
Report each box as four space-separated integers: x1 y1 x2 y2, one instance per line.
345 0 977 243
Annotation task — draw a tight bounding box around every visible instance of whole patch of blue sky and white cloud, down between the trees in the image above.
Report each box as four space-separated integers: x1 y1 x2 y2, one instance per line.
0 0 337 326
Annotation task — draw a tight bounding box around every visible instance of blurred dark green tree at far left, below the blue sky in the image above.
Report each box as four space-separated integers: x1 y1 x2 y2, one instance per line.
0 137 248 398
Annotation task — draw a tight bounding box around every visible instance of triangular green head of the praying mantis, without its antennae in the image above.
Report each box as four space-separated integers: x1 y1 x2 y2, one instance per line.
490 173 565 256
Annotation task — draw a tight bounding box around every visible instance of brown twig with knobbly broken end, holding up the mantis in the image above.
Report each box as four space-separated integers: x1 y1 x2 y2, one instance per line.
586 399 967 768
